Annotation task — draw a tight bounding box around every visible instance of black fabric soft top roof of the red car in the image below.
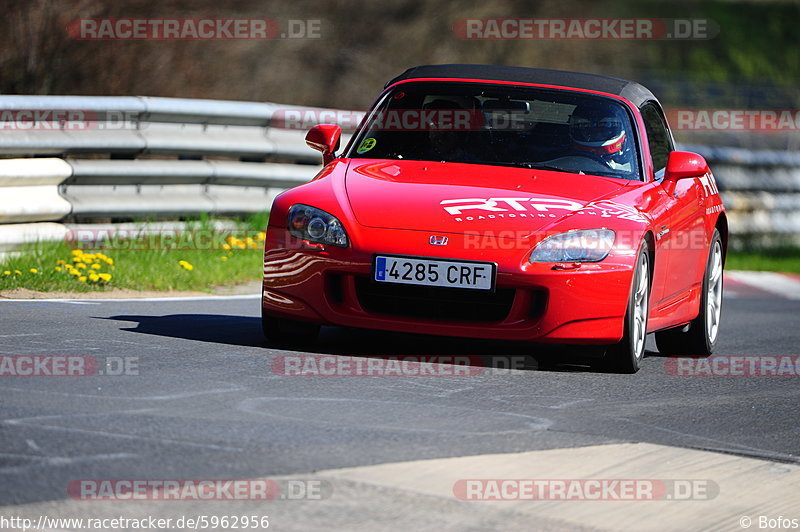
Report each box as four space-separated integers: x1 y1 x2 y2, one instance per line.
386 65 658 107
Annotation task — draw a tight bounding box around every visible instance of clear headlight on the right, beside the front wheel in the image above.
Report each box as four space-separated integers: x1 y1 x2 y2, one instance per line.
528 229 615 262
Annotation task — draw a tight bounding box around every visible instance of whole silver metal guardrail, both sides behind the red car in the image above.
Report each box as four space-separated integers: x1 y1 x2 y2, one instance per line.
0 95 800 249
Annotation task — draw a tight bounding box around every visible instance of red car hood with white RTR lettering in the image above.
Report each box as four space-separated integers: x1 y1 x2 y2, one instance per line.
345 159 627 233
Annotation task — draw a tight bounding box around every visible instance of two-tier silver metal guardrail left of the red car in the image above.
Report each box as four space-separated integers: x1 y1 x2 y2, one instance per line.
0 96 358 233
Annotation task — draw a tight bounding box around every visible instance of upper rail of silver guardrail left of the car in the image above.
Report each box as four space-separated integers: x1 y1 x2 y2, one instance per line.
0 96 319 164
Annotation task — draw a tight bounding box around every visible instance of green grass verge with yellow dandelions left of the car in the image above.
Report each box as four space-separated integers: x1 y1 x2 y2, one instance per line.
0 214 267 292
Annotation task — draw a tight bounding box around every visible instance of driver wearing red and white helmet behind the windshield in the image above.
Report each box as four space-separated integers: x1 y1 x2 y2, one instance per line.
569 107 634 172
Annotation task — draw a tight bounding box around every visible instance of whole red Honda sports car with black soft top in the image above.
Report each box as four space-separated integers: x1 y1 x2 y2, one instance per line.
262 65 728 372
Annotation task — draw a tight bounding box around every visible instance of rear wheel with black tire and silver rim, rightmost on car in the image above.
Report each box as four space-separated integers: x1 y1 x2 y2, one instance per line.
656 229 724 357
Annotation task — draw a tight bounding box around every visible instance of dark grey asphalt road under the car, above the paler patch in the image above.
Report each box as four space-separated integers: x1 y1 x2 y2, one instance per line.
0 288 800 505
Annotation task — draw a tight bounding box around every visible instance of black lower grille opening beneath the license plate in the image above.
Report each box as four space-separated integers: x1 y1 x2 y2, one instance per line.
356 278 515 322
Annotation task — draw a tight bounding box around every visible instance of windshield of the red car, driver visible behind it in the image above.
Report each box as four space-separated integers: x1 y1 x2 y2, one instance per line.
348 82 639 179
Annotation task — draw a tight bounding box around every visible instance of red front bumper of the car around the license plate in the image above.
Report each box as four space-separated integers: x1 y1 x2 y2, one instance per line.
262 223 633 344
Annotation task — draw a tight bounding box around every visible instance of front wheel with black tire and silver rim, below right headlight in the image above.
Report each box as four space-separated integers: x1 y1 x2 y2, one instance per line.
602 242 650 373
